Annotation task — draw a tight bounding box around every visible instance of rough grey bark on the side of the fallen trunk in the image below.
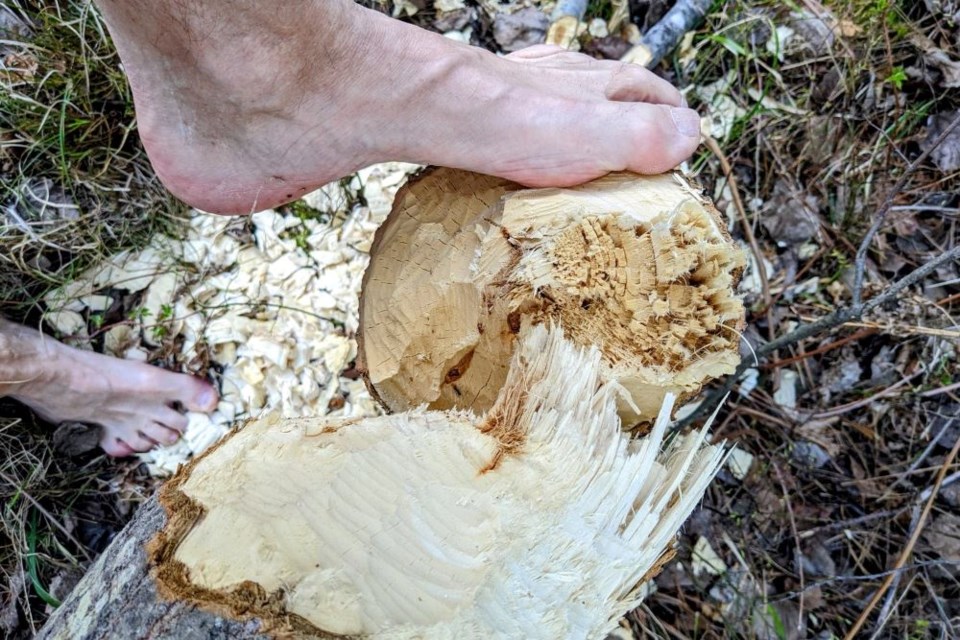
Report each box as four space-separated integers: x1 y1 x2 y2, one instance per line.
37 496 269 640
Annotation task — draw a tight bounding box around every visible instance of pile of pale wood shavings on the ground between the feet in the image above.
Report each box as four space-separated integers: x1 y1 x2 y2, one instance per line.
46 163 418 475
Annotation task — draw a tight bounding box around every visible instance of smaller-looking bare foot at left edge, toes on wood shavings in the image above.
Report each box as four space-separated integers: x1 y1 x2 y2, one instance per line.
0 320 217 456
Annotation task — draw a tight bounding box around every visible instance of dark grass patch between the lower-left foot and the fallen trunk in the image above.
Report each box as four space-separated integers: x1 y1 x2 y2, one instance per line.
0 401 149 638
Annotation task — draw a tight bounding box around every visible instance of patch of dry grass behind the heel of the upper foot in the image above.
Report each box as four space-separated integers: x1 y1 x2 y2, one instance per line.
0 0 180 317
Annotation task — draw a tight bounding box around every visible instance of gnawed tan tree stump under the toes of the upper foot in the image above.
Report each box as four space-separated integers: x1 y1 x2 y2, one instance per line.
359 169 745 426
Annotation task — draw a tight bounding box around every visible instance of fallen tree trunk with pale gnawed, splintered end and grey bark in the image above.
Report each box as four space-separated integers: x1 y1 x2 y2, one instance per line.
43 326 722 640
